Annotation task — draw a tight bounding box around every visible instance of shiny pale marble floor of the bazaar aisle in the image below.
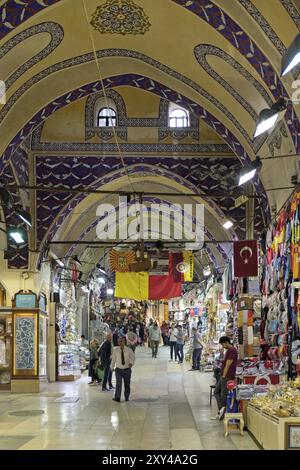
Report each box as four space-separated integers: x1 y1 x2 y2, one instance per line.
0 347 257 450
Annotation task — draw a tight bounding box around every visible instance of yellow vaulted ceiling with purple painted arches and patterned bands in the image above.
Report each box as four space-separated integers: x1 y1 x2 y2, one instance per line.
0 0 300 278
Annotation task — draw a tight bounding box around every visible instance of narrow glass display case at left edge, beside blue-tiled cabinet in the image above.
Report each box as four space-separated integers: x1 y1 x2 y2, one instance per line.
0 313 12 390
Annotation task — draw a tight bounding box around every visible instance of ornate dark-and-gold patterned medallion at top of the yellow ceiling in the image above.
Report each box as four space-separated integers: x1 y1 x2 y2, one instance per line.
91 0 151 35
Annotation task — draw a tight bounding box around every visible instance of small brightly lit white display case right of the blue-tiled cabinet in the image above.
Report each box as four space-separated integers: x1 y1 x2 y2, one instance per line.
57 343 81 381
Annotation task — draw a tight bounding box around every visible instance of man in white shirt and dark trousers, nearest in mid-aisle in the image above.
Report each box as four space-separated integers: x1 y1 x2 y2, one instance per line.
111 337 135 402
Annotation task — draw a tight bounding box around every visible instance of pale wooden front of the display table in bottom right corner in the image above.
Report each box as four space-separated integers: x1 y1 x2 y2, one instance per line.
247 403 300 450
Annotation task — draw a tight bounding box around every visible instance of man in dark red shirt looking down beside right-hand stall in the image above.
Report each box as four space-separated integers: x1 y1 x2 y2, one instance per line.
214 336 238 420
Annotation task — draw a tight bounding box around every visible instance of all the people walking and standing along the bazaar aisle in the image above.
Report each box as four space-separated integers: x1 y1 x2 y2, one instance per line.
85 319 238 419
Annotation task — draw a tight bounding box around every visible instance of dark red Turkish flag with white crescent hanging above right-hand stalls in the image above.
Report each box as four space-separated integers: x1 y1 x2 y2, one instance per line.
233 240 258 277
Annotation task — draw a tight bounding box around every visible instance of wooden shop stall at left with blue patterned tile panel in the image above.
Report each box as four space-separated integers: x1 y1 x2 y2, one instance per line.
0 291 48 393
